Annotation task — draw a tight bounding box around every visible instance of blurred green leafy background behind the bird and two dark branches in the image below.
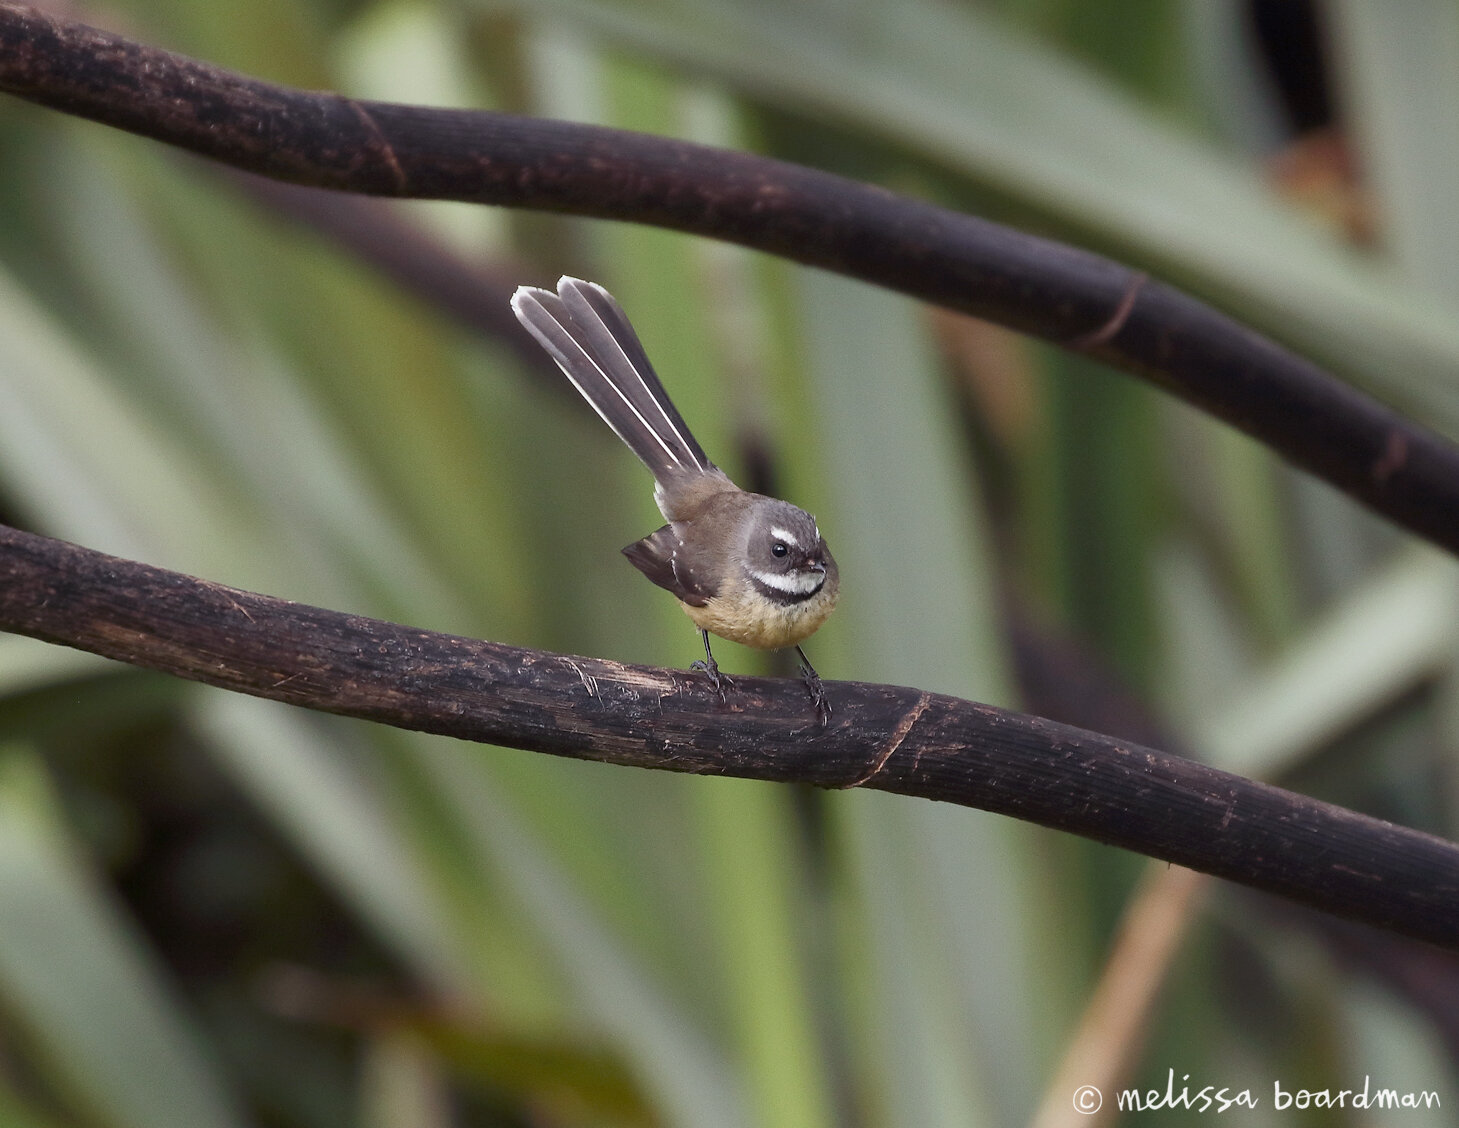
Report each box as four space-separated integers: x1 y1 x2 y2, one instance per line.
0 0 1459 1128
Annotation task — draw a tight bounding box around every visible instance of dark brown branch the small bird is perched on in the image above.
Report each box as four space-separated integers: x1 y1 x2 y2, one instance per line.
0 527 1459 950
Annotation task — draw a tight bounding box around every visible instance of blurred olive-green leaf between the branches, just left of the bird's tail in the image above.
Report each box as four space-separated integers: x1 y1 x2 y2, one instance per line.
131 153 541 639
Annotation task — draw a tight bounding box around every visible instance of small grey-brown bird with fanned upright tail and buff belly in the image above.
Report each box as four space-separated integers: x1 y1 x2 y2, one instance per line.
512 276 840 727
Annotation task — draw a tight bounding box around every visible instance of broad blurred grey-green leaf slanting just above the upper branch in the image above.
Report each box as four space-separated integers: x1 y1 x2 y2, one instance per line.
492 0 1459 433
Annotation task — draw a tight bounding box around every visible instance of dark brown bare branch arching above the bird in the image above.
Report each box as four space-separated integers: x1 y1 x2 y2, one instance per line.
8 0 1459 552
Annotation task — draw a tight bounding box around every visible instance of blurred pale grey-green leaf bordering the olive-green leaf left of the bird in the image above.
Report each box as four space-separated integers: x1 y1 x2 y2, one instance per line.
50 132 464 622
